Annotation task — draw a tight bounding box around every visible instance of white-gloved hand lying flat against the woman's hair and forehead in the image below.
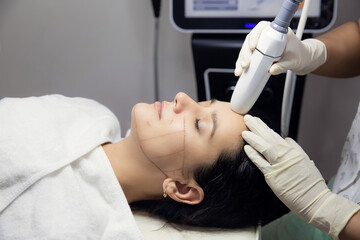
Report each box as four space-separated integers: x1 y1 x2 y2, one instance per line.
242 115 360 239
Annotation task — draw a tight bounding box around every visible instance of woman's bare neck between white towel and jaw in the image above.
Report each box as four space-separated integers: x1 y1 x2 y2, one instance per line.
103 135 165 203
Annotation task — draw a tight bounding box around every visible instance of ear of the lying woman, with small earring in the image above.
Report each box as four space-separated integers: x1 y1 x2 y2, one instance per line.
163 178 204 205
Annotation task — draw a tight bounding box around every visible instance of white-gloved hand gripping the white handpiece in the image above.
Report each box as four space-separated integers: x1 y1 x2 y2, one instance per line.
234 21 326 76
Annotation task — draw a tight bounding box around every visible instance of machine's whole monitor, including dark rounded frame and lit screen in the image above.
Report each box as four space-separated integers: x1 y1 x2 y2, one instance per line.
170 0 337 34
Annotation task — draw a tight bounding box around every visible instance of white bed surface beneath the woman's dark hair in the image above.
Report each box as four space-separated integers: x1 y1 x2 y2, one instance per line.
134 212 260 240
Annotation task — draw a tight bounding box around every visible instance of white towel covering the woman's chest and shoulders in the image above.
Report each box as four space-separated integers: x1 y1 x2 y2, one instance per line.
0 95 142 239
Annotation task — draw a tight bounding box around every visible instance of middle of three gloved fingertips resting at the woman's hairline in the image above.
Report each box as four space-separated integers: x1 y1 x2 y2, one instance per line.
242 131 278 164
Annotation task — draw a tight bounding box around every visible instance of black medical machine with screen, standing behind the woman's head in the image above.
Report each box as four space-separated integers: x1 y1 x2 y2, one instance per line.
170 0 337 139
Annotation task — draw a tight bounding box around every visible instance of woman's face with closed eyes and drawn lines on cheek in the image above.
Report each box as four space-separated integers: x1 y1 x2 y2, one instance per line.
131 93 246 179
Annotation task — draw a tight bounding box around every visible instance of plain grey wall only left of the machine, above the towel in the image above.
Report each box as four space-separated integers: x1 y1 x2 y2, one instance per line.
0 0 196 132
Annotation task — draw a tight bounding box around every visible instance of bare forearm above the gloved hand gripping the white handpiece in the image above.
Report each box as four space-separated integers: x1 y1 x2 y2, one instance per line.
313 19 360 77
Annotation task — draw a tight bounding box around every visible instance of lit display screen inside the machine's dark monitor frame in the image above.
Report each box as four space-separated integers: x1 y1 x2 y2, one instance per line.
185 0 321 18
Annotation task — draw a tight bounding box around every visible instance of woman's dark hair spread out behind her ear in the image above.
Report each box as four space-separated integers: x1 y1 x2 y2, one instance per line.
131 144 289 228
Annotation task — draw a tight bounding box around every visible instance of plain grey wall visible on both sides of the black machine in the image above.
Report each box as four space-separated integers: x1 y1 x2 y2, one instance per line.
0 0 360 178
